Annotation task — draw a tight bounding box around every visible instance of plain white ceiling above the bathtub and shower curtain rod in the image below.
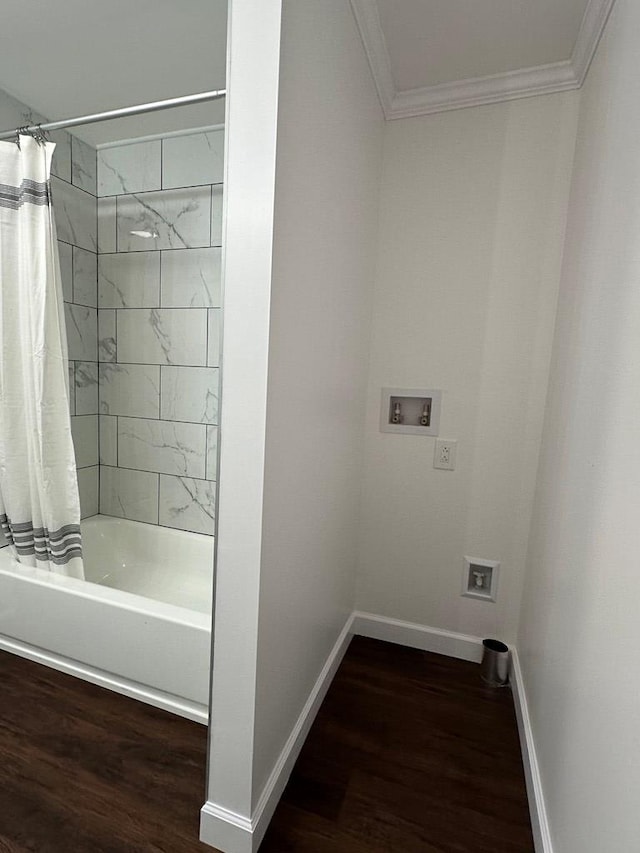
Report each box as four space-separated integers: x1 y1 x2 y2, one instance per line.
0 0 227 145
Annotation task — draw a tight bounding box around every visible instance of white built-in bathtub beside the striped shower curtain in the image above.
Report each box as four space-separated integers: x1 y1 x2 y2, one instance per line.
0 515 213 723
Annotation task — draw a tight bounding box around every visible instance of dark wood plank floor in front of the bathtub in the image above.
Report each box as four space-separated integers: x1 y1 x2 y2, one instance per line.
0 652 212 853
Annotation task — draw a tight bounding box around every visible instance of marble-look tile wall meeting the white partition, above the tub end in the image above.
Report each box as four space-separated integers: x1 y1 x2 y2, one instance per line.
98 131 224 534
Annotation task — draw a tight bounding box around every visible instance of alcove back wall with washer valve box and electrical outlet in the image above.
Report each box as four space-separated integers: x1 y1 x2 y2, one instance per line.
357 92 578 641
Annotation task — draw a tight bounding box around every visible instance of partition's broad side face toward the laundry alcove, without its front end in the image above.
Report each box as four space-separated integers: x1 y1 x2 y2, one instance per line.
254 0 383 796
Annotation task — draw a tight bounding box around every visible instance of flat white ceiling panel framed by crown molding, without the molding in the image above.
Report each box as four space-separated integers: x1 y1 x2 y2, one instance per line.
377 0 587 90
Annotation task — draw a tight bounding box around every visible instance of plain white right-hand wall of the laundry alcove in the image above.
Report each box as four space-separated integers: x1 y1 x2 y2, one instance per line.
518 0 640 853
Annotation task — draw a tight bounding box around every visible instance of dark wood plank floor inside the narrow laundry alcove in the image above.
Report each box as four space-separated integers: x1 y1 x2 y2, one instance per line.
260 637 534 853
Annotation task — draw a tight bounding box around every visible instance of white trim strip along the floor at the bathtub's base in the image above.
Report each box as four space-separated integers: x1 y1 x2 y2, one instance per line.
0 635 209 726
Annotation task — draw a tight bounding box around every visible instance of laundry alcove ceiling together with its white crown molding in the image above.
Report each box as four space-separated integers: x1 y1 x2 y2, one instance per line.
351 0 615 119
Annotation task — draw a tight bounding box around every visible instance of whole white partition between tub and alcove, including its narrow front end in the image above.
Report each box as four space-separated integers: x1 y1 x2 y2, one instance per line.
201 0 383 851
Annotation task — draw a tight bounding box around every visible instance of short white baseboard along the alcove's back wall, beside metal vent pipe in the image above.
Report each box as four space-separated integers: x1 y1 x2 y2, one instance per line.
352 610 482 663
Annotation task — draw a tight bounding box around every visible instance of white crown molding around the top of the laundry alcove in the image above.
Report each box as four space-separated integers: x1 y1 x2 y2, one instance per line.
351 0 615 120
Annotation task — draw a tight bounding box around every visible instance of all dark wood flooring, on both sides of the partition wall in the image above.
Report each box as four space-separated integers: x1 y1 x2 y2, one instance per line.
0 637 533 853
